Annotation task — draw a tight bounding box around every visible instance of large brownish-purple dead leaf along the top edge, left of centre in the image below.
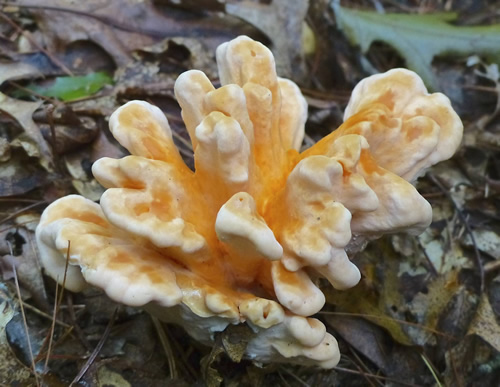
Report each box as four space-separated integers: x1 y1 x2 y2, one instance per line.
17 0 250 66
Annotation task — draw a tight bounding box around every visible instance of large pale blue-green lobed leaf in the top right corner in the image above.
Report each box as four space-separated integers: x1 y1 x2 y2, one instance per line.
333 2 500 89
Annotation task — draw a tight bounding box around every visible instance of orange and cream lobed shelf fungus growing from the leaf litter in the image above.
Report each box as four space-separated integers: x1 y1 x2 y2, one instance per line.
37 37 462 368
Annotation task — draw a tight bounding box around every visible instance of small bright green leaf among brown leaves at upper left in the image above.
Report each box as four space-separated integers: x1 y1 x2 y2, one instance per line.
28 72 113 101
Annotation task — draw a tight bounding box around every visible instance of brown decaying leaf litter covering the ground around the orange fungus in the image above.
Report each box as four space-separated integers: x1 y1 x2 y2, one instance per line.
0 0 500 386
